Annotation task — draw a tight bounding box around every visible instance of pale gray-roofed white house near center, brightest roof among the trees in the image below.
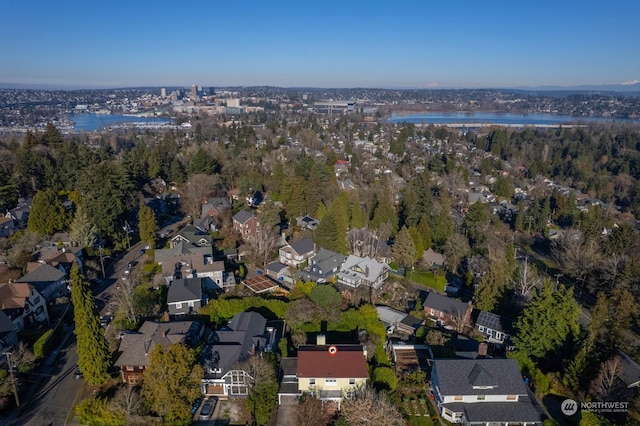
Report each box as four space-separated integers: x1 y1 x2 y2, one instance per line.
337 255 391 290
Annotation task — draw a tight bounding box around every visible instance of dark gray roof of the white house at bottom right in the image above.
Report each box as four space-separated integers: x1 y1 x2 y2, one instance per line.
433 359 527 395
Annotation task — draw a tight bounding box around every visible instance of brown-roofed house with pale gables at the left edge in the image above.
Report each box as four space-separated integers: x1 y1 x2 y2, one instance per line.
0 282 49 332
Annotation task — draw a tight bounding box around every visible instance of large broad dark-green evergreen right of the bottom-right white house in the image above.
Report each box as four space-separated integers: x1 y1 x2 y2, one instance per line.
513 279 580 358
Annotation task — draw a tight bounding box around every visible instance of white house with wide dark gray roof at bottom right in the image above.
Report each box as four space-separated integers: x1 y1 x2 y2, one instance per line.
431 358 545 426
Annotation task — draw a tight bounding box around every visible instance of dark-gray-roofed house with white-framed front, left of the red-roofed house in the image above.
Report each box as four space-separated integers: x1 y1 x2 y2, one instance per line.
200 312 276 398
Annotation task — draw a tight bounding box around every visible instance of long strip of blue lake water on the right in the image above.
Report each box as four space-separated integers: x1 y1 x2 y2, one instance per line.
388 112 640 126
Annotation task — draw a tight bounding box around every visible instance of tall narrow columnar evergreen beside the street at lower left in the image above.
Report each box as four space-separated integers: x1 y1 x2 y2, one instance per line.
71 262 109 385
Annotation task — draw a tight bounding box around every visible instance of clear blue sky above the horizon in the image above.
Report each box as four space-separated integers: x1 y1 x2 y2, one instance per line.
0 0 640 88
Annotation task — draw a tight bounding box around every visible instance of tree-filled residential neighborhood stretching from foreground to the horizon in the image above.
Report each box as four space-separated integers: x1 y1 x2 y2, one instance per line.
0 86 640 425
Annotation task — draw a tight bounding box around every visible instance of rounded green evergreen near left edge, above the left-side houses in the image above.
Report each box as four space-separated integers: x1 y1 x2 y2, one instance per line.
27 189 68 235
